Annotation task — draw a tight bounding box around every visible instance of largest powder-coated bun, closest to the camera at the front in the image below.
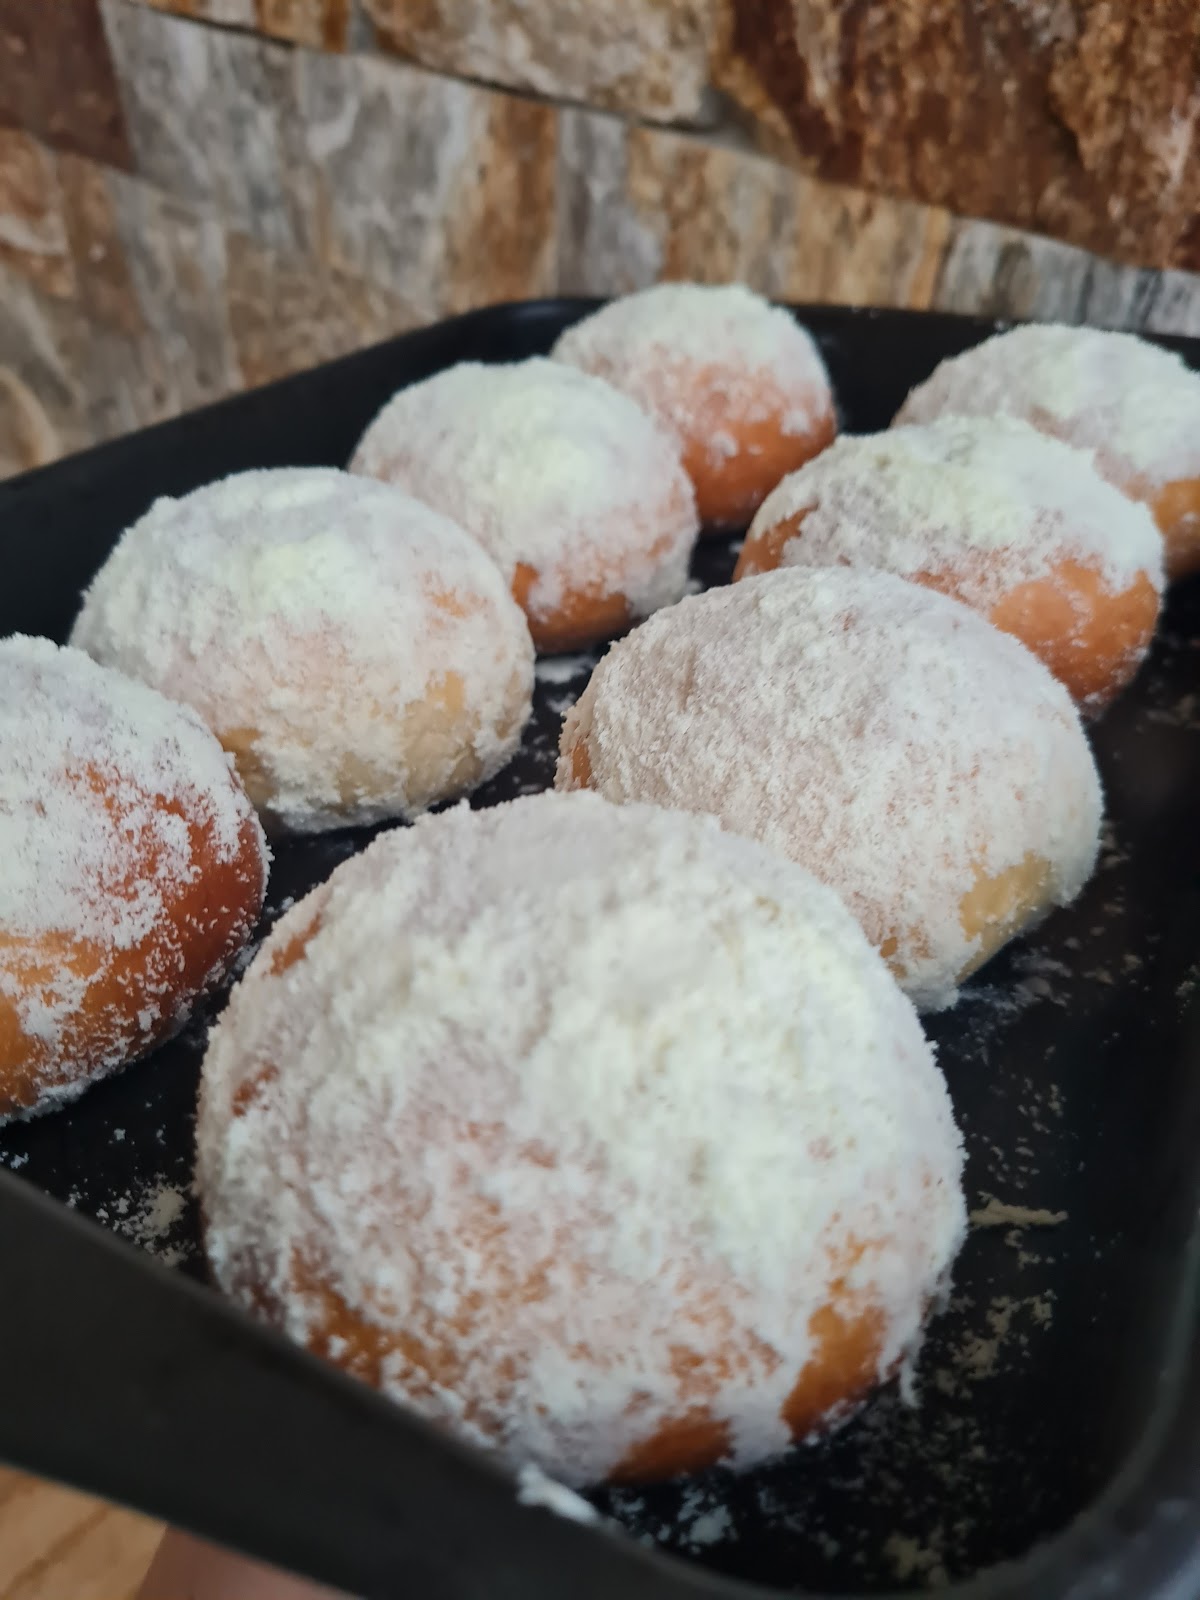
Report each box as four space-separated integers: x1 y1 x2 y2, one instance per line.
198 794 963 1485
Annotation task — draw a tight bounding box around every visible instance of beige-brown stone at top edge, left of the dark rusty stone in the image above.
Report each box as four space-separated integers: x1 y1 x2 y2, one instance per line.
365 0 717 122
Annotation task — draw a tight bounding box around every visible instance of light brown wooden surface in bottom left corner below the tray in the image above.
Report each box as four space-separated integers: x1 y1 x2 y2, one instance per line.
0 1467 162 1600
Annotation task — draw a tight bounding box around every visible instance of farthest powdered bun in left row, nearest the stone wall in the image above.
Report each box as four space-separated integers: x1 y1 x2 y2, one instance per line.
554 283 837 530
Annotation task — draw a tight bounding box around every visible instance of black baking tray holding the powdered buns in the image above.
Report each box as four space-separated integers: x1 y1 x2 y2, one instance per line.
0 301 1200 1600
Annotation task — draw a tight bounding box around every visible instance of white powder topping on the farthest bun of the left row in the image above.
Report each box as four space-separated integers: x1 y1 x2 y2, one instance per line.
554 283 832 448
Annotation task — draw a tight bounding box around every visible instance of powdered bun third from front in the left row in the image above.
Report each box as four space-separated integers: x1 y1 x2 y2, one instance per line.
350 360 698 651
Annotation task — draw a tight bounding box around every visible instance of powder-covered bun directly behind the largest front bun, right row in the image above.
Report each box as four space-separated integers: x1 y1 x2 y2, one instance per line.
557 566 1101 1010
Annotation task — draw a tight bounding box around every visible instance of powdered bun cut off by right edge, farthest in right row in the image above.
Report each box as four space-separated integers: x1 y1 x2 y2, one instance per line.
896 323 1200 578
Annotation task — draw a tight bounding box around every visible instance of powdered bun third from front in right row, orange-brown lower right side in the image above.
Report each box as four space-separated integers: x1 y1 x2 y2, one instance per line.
734 416 1163 714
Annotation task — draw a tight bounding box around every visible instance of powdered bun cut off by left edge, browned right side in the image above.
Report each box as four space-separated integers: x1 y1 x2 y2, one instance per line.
0 635 269 1122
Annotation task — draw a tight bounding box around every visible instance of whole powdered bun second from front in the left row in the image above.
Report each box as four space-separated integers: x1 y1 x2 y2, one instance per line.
72 467 533 834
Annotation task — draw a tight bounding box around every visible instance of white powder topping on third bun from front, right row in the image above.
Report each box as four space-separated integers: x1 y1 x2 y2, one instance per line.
750 416 1163 611
